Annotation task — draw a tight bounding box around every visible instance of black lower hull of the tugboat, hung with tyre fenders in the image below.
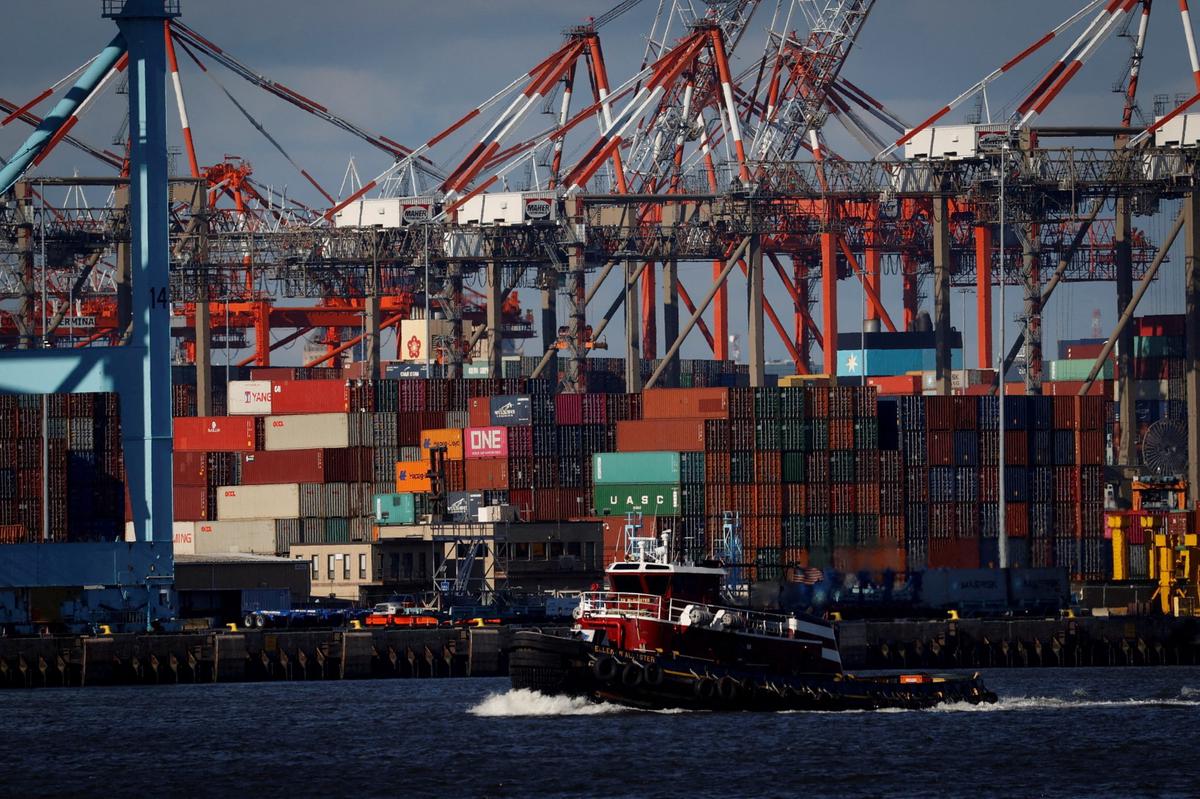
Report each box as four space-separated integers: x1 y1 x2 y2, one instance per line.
509 631 996 711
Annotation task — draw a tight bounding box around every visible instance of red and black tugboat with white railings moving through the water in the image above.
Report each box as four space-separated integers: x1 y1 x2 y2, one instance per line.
509 525 996 710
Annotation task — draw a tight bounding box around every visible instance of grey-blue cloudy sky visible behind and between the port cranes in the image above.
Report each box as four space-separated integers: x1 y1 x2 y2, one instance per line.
0 0 1194 367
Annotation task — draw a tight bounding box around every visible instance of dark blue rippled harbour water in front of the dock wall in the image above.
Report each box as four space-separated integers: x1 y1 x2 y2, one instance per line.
0 668 1200 799
